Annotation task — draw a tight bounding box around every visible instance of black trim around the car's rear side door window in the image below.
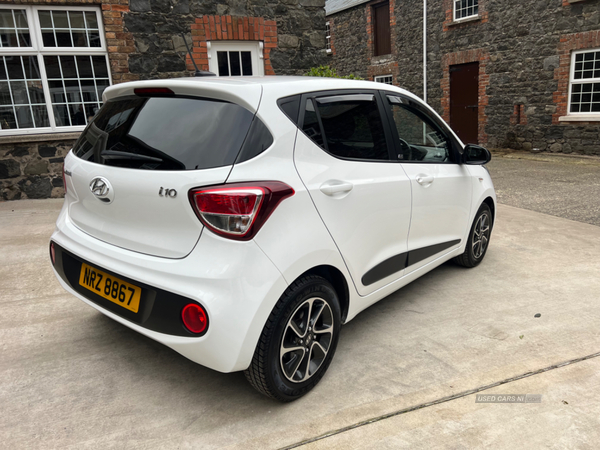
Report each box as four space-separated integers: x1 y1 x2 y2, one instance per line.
298 89 398 163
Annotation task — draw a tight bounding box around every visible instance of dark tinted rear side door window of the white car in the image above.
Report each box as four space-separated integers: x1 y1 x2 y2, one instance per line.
302 94 390 161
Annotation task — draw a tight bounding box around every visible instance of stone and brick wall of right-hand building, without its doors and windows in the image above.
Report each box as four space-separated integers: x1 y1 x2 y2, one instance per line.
327 0 600 155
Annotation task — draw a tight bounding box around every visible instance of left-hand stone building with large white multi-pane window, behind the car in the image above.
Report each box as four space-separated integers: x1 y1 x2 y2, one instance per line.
0 0 327 201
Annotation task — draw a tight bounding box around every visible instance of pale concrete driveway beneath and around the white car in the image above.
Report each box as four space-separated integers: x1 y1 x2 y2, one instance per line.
0 200 600 449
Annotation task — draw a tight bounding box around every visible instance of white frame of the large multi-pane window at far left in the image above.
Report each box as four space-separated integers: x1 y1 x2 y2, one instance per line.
0 4 112 136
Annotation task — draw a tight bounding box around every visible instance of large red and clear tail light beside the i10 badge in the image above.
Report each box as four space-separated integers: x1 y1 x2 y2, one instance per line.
189 181 294 241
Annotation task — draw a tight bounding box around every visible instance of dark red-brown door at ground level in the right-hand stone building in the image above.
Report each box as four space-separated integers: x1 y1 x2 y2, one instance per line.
450 62 479 144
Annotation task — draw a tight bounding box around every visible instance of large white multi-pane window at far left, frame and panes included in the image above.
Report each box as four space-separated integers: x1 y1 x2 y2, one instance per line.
0 5 111 136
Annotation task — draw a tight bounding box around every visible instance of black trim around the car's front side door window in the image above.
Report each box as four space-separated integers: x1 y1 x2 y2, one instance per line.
379 90 462 164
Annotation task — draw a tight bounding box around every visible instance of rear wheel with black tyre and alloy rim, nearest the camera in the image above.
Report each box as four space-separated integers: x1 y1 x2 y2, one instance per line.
244 275 341 402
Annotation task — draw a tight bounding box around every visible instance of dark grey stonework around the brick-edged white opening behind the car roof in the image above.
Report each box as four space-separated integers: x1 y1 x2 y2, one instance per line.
124 0 326 79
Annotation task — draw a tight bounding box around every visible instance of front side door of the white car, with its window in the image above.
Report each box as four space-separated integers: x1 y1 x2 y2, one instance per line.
387 95 473 274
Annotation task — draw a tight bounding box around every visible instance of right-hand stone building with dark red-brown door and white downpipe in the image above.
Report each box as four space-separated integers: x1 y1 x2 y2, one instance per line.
326 0 600 155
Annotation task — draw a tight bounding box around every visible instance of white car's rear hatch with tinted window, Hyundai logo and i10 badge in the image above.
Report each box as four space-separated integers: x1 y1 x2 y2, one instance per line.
65 90 254 258
